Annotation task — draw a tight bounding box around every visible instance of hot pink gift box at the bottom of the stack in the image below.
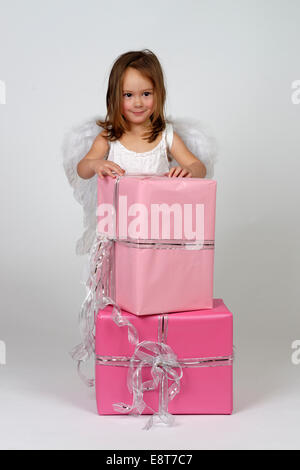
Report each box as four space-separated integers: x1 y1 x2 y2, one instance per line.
95 299 233 415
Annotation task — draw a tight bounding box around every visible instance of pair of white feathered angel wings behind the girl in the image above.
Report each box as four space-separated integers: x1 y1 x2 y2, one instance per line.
63 117 217 255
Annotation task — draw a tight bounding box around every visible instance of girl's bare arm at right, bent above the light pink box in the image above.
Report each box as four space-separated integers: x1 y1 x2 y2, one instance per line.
169 132 206 178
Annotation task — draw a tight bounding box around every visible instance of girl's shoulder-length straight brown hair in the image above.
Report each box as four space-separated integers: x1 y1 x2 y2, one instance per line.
96 49 166 142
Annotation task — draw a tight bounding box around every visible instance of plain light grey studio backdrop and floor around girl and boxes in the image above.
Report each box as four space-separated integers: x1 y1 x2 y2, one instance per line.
0 0 300 449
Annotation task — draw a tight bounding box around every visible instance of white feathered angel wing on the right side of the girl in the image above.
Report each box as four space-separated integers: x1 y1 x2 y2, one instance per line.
168 117 217 178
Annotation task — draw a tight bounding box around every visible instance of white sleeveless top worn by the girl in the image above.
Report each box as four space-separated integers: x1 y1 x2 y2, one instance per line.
107 123 173 174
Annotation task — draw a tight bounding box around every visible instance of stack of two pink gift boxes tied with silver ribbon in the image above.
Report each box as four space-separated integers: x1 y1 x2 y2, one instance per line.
95 175 233 421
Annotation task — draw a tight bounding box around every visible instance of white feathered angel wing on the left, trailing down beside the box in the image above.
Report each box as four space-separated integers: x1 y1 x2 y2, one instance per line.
62 119 102 255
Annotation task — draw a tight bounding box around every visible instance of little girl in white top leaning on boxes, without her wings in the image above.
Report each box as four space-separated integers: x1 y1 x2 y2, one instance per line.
77 50 206 179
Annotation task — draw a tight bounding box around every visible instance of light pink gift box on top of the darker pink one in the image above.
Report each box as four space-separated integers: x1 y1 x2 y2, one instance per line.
98 176 216 315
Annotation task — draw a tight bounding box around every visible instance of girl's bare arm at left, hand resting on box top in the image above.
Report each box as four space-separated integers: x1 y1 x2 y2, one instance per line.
77 130 124 179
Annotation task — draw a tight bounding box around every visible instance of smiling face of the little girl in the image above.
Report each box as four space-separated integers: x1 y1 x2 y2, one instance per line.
122 67 154 124
